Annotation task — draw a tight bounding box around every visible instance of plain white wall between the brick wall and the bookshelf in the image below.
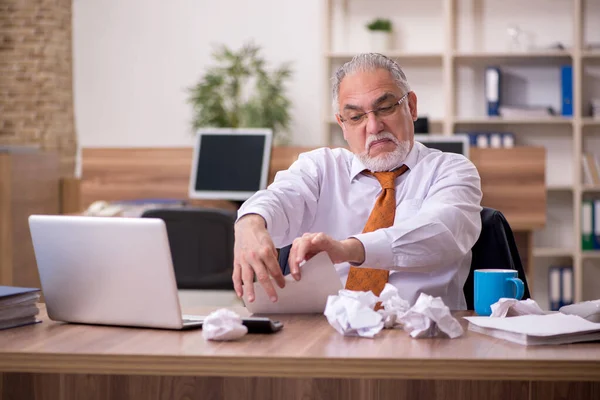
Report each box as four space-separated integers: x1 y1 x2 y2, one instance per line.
73 0 324 147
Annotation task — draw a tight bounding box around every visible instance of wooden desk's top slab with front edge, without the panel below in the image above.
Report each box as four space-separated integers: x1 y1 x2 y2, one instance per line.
0 305 600 381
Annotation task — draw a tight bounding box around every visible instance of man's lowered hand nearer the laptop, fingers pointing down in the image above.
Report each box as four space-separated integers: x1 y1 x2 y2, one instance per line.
232 214 285 302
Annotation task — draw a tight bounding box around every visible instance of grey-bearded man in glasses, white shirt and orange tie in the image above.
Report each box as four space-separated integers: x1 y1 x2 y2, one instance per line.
233 54 482 309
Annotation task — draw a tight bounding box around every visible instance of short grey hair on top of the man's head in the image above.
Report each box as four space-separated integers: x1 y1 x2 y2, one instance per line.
332 53 410 113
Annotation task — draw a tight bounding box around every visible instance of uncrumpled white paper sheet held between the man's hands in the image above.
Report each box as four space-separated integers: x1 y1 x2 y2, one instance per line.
243 252 343 314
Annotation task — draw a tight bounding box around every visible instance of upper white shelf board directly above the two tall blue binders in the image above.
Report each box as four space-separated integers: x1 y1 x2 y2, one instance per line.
454 50 571 64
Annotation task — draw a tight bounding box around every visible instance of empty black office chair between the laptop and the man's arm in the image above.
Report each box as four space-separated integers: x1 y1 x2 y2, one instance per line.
142 208 236 290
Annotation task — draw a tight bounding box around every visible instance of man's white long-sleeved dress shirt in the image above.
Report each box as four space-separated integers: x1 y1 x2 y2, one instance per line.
238 142 482 310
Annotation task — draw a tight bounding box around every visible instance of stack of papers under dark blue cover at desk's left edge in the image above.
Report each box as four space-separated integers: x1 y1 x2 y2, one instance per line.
0 286 40 329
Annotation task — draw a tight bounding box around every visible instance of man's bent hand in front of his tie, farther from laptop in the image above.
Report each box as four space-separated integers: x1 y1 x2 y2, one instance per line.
288 233 365 280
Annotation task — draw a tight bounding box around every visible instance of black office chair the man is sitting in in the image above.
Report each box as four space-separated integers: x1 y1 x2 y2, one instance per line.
279 207 531 310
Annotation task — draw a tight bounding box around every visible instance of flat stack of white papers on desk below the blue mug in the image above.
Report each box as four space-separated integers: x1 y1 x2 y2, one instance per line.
464 313 600 345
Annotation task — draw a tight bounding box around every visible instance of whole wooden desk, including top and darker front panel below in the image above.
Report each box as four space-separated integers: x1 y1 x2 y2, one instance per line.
0 309 600 400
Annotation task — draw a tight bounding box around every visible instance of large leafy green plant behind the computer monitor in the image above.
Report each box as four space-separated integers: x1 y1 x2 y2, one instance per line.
188 43 292 144
